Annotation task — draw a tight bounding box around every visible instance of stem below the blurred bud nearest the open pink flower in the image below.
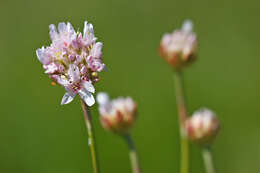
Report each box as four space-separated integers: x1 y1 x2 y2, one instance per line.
122 134 141 173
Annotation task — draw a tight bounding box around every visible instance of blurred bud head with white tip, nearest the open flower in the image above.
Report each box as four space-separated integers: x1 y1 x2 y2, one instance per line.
97 93 137 134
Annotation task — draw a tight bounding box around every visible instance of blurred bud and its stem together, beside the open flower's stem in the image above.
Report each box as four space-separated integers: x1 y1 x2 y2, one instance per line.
97 93 141 173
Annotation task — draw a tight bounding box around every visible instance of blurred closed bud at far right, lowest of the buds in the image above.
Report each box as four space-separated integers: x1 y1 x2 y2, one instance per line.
186 109 219 145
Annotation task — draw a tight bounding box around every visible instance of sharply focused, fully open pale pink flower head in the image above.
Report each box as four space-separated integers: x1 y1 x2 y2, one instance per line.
36 22 105 106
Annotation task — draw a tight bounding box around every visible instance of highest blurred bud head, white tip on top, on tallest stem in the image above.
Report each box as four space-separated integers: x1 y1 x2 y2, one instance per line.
159 20 198 68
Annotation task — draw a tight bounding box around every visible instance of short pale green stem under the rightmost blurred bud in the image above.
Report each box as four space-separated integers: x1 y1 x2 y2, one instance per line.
202 147 215 173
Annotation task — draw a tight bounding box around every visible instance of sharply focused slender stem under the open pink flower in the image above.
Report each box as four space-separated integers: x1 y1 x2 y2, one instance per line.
80 100 100 173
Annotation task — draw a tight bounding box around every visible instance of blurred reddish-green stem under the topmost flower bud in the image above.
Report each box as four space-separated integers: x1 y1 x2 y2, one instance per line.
174 70 189 173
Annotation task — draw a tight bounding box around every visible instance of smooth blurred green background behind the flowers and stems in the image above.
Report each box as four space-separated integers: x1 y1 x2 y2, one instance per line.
0 0 260 173
